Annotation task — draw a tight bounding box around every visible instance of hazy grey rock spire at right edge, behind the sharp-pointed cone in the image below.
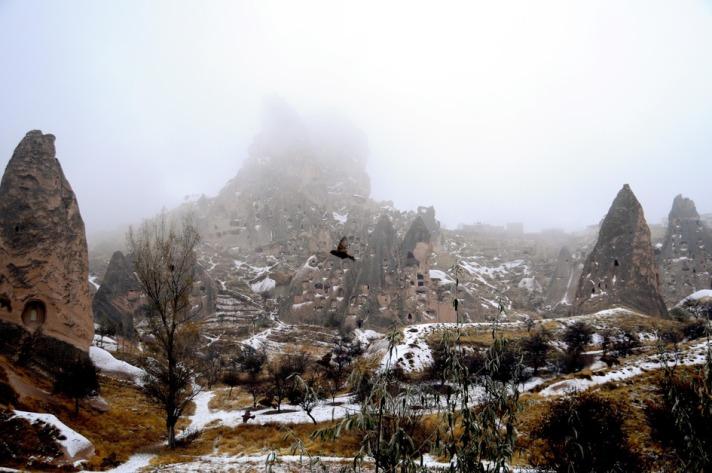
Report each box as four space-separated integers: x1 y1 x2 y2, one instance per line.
658 195 712 305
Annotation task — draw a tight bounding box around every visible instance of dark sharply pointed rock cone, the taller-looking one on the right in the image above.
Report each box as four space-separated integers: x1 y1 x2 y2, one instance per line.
574 184 667 316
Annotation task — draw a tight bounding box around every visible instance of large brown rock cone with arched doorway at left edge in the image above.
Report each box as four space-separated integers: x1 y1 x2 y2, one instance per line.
0 131 94 350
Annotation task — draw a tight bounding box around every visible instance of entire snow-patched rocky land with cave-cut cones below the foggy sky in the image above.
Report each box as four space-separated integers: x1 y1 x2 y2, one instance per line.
0 110 712 472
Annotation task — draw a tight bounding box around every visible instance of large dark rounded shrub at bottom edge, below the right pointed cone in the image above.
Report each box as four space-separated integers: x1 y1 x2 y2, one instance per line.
529 392 641 473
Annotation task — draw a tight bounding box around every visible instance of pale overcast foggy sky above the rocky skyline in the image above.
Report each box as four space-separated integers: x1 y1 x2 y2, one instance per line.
0 0 712 236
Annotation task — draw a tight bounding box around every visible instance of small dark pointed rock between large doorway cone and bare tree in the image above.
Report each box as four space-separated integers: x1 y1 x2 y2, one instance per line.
92 251 141 338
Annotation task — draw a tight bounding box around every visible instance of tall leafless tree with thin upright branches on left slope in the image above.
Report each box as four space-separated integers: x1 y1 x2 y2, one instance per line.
128 215 200 448
